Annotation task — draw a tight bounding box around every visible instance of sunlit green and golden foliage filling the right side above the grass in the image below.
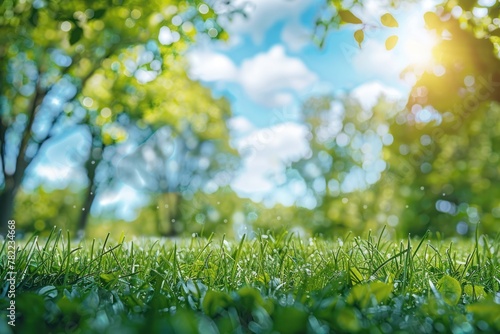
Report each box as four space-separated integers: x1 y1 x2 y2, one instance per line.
293 1 500 235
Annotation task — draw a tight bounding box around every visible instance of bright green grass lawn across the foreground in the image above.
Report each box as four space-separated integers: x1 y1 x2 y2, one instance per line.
0 232 500 333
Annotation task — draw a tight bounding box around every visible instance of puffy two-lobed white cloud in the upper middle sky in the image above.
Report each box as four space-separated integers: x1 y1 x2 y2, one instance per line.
189 45 317 108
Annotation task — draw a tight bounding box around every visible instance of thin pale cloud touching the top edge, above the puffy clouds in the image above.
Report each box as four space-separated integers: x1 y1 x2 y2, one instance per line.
221 0 314 43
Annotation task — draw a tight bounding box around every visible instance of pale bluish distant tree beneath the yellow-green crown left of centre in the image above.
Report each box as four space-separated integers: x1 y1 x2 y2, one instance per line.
117 116 237 236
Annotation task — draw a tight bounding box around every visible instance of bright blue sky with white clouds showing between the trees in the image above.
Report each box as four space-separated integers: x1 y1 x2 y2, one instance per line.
31 0 440 218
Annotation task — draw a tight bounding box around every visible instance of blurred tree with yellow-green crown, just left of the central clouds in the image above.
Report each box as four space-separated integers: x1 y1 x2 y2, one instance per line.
78 52 235 234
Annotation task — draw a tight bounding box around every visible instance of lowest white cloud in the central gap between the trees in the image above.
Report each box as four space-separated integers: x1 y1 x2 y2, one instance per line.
231 122 310 196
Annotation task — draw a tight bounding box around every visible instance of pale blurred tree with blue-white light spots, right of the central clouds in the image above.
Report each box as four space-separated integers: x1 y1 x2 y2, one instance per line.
292 94 401 234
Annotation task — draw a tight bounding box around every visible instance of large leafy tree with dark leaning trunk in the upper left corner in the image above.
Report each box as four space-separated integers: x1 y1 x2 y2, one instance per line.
0 0 232 232
